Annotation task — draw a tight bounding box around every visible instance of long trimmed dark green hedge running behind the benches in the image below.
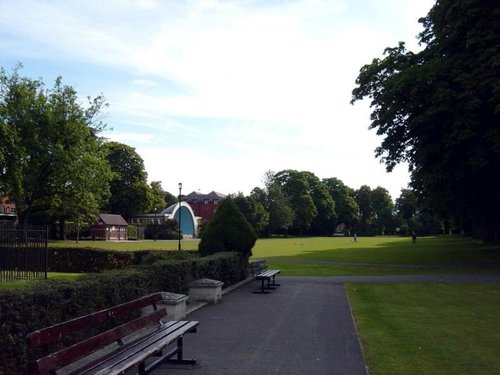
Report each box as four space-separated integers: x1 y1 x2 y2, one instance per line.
0 249 248 374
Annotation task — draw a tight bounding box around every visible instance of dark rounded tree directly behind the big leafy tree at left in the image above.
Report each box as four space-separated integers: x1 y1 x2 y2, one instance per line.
106 142 153 219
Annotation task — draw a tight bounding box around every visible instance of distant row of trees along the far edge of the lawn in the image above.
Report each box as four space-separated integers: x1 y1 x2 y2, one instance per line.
233 170 444 236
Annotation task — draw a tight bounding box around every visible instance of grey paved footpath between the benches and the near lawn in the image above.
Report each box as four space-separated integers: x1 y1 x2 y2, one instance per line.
160 277 366 375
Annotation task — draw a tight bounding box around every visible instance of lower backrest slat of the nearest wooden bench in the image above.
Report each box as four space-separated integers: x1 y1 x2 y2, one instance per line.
29 308 167 374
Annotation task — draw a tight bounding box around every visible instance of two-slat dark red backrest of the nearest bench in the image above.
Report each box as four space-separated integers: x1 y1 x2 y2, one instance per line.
26 293 167 374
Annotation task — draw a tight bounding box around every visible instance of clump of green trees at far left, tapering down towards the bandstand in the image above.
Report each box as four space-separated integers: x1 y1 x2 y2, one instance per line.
0 65 176 235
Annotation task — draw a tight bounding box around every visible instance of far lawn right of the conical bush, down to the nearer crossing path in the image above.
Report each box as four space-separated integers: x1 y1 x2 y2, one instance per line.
253 236 500 276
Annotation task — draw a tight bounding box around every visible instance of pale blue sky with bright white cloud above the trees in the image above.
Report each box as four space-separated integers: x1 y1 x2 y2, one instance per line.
0 0 434 199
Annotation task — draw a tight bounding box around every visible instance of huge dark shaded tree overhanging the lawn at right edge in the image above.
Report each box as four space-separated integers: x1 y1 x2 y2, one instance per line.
352 0 500 242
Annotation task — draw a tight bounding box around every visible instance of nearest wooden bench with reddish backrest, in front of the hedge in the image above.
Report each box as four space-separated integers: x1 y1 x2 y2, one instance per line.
26 293 198 375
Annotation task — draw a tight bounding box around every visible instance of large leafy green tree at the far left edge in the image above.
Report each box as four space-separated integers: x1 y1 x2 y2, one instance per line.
0 66 110 226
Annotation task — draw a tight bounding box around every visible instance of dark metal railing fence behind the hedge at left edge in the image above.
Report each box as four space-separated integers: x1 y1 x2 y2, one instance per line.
0 225 48 282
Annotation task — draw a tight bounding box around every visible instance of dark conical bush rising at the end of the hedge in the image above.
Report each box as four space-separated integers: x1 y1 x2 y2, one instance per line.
198 198 257 257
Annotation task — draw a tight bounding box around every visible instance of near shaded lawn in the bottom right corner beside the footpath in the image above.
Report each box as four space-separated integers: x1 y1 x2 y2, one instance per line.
347 283 500 375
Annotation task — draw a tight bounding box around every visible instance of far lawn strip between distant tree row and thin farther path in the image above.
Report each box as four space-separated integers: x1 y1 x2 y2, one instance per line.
253 236 500 266
